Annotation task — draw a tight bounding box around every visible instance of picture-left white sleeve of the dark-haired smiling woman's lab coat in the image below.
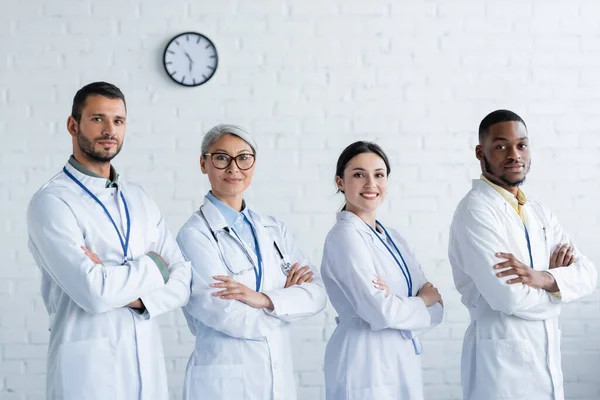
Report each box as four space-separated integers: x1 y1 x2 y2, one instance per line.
321 229 431 331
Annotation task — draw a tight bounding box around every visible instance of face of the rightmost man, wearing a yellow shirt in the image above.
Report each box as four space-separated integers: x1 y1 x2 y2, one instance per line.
476 121 531 194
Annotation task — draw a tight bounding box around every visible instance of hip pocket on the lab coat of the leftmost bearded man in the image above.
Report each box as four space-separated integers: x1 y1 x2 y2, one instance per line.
59 338 117 400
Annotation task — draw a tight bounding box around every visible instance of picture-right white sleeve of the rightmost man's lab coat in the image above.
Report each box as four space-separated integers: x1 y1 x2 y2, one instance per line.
548 214 598 303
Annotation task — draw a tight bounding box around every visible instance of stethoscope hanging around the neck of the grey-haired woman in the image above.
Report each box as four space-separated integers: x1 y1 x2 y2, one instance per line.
200 207 292 292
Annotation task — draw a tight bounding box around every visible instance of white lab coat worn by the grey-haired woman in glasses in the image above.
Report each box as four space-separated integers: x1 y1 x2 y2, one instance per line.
177 198 327 400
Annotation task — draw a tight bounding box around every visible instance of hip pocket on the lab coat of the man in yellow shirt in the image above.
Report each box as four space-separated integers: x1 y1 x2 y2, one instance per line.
476 339 533 400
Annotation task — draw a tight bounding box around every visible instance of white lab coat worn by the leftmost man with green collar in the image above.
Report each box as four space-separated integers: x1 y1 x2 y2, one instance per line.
27 164 191 400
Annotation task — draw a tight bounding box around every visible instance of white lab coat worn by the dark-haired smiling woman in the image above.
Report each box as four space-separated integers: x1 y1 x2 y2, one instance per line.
321 211 443 400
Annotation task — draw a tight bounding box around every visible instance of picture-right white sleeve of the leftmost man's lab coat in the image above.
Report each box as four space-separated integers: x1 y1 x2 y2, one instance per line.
141 209 192 318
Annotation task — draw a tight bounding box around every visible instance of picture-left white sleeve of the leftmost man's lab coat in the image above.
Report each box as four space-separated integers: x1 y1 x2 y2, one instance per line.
27 194 164 313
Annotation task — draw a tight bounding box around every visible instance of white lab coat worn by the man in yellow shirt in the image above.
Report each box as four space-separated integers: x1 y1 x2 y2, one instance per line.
448 180 597 400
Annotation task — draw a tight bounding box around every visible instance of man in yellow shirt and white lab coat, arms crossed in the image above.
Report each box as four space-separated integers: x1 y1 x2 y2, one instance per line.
448 110 597 400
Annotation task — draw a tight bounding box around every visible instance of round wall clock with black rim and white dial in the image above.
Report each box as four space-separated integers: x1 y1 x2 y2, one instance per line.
163 32 219 86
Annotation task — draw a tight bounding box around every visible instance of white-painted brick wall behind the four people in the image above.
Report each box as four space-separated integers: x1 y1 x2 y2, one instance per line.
0 0 600 400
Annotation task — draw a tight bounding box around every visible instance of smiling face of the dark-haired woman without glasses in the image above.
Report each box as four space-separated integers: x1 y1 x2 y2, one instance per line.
336 153 388 219
